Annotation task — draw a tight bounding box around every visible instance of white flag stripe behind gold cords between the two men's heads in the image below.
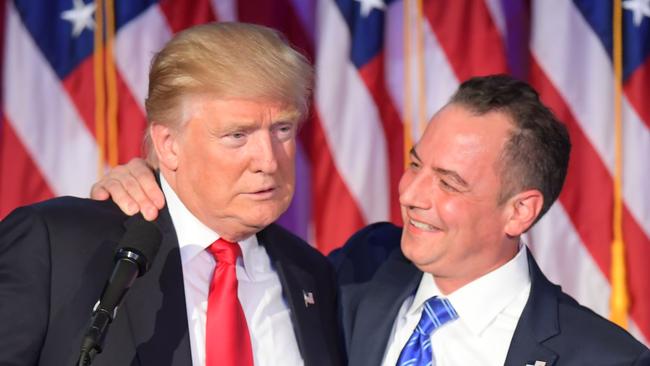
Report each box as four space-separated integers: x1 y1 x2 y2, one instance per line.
385 2 458 140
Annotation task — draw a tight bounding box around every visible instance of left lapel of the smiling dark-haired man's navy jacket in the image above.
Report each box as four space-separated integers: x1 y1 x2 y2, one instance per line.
348 251 422 366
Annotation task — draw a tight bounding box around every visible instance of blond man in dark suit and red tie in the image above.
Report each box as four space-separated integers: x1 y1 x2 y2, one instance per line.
0 23 342 366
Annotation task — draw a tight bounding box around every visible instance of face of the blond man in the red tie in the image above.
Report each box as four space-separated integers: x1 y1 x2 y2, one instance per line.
170 96 298 241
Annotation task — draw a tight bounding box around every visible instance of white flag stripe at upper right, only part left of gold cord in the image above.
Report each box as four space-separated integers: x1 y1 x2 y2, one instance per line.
531 0 614 177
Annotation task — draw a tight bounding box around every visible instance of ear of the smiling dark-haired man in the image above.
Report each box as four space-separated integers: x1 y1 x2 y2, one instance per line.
505 189 544 237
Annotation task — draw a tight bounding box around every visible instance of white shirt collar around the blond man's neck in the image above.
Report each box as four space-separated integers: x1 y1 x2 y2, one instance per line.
160 174 271 277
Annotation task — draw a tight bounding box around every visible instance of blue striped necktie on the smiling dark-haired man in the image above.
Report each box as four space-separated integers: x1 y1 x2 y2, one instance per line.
397 296 458 366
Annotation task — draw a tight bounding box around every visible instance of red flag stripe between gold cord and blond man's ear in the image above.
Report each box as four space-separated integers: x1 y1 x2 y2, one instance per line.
117 72 147 164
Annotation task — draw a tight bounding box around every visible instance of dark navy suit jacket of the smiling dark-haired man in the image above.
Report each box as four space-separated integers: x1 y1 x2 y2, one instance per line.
331 223 650 366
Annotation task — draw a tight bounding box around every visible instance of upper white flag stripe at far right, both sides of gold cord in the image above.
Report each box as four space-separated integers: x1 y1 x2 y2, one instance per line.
532 0 650 237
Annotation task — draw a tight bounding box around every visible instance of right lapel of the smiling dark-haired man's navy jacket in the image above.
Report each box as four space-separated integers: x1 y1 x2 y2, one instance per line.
505 251 560 366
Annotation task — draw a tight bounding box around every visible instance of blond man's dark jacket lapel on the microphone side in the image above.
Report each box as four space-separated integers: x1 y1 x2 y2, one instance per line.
125 207 192 366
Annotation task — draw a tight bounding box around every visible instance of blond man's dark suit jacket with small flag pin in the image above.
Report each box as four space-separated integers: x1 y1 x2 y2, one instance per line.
0 197 342 366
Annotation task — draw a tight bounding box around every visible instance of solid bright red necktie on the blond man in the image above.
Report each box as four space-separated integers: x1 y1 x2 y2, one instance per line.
205 239 253 366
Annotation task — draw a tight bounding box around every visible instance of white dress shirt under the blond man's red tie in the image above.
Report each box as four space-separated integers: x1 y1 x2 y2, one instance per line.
160 175 303 366
